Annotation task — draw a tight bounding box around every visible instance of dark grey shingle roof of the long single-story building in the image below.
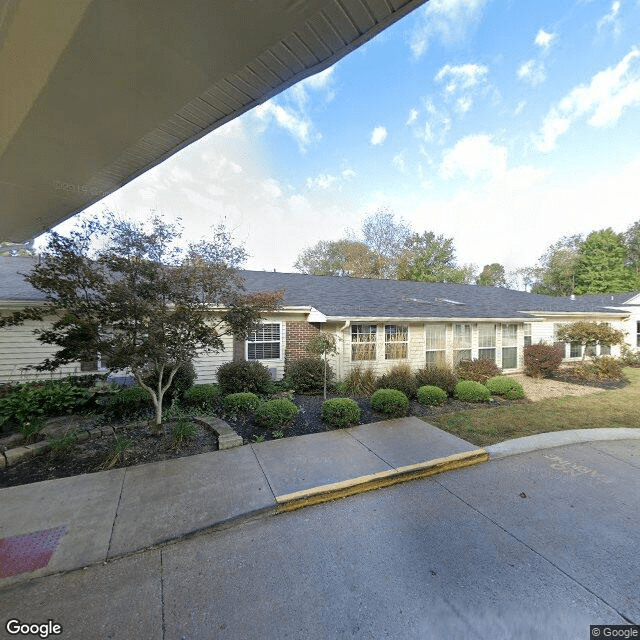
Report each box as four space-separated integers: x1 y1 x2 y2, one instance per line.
0 257 637 318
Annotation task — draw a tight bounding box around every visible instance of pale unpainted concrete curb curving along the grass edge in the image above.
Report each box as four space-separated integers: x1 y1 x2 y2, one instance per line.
486 427 640 460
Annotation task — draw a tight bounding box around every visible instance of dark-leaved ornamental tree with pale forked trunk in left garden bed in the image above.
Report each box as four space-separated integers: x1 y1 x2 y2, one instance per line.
0 215 281 430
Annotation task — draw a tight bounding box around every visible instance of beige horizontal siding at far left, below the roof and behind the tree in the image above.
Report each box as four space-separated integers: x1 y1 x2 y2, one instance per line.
0 321 80 382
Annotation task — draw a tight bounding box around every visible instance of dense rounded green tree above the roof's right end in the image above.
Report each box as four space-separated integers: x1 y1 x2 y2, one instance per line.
575 228 638 294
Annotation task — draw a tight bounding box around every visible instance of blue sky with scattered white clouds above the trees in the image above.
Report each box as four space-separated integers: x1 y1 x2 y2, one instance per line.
42 0 640 282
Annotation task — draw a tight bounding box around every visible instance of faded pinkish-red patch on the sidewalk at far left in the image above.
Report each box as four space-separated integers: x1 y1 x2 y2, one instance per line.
0 526 67 578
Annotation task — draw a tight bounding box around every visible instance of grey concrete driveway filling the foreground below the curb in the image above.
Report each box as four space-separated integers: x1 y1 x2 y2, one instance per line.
0 440 640 640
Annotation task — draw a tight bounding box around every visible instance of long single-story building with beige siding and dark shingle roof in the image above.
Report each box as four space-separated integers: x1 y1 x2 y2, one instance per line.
0 258 640 382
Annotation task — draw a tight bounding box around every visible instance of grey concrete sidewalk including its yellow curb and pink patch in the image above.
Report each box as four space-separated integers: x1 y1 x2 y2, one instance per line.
0 417 488 588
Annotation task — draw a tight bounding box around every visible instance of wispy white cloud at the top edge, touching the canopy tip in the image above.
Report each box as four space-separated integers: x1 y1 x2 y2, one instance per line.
410 0 488 58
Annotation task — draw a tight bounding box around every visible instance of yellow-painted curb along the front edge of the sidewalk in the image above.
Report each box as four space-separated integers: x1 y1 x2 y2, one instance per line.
276 449 489 513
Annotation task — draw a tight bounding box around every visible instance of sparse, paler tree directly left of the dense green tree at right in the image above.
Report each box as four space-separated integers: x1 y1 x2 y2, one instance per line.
531 234 582 296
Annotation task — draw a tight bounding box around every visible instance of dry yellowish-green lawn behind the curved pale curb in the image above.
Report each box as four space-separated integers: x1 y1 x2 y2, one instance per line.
425 368 640 446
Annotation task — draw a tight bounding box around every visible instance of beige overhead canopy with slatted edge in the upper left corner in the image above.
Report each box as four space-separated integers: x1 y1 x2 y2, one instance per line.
0 0 425 242
